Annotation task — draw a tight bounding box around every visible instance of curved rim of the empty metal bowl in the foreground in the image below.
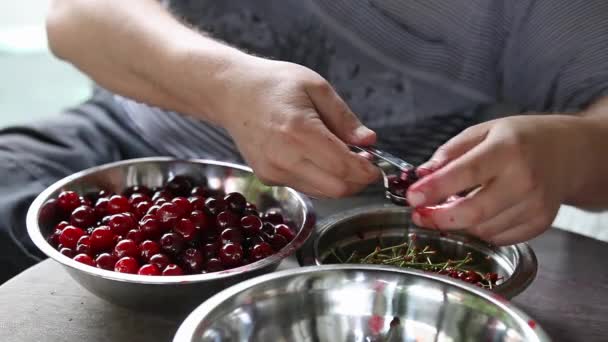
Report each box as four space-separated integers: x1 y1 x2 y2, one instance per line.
173 265 551 342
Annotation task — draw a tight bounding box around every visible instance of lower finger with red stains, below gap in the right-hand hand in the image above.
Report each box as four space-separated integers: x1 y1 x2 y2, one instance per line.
420 176 526 229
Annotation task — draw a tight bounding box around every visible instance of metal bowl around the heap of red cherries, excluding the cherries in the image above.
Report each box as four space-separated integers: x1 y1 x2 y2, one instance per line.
27 158 315 312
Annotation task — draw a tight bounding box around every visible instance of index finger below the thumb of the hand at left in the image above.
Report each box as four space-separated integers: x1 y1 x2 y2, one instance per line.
299 120 380 185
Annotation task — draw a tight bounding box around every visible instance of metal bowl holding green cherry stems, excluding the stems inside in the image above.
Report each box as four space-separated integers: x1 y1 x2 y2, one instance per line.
300 205 537 298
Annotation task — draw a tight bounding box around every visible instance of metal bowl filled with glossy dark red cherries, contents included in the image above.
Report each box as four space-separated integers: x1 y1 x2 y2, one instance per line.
27 158 315 311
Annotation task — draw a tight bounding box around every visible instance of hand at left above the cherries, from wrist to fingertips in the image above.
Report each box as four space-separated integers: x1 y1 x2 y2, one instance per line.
217 56 380 198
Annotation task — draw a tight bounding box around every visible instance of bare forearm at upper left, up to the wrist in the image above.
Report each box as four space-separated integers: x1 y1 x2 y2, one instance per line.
47 0 246 123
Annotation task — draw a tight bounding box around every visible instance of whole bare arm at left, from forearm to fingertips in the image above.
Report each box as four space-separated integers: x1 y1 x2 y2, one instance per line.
47 0 378 197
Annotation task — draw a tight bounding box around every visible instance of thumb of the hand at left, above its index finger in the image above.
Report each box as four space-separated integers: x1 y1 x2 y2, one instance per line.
306 79 376 146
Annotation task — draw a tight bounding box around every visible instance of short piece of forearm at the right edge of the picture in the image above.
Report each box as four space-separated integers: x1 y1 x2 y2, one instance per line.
564 97 608 210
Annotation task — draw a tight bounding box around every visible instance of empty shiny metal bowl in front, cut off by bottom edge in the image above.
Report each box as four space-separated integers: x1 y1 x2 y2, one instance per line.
173 265 549 342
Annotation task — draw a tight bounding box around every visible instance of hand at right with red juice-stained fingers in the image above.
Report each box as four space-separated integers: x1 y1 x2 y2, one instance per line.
407 115 585 245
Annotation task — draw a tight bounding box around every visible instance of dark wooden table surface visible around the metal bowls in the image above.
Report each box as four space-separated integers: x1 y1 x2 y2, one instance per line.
0 199 608 342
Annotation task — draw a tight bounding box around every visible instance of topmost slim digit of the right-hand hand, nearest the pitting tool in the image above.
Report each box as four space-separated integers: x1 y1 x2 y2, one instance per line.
418 124 489 171
